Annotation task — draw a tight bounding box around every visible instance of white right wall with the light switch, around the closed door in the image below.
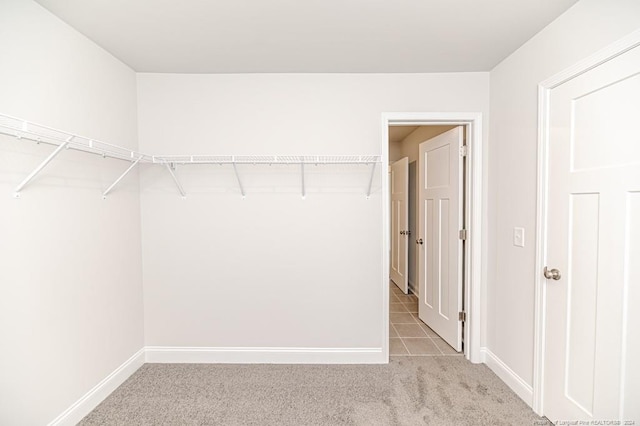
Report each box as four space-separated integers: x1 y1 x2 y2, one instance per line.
487 0 640 394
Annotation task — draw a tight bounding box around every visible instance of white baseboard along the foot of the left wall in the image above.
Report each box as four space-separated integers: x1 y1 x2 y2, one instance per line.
49 348 144 426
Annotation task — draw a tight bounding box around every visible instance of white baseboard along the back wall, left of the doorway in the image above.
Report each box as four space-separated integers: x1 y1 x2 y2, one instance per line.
145 346 388 364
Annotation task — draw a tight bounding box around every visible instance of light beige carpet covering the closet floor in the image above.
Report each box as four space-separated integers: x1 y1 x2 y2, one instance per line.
80 356 543 426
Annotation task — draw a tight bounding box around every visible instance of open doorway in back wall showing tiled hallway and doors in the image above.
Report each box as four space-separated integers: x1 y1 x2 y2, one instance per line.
389 125 465 355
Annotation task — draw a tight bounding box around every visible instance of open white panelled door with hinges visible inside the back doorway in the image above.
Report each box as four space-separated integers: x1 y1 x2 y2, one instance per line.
416 127 464 351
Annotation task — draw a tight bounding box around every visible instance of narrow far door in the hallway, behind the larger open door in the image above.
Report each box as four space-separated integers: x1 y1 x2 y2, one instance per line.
390 157 409 294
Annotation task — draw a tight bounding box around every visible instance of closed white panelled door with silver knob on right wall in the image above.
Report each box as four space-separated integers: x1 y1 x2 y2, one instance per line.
539 42 640 421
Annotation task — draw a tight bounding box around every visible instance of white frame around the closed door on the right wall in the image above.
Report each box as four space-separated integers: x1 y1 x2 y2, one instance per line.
532 30 640 415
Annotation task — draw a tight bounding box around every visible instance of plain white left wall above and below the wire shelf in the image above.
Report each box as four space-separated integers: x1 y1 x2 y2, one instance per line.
0 0 143 425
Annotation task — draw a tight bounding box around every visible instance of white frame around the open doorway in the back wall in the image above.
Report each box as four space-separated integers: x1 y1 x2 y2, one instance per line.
382 112 486 363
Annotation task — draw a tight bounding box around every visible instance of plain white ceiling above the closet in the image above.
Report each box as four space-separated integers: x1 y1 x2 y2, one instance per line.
36 0 577 73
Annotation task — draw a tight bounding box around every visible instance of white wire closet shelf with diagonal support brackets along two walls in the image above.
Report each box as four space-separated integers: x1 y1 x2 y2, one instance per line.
0 114 382 198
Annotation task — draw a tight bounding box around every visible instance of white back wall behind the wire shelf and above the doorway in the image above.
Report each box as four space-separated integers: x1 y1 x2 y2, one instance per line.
138 73 489 348
